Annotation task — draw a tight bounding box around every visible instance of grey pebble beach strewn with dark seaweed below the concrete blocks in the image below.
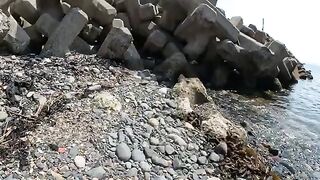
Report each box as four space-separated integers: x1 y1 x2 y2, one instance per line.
0 54 272 179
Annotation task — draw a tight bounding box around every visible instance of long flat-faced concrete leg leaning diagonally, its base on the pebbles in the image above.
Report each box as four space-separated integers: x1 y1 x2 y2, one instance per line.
41 8 88 56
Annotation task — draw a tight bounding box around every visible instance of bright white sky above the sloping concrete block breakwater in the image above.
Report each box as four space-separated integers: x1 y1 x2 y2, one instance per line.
217 0 320 65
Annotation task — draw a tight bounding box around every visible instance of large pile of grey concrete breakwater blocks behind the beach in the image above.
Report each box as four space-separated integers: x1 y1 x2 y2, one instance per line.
0 0 312 90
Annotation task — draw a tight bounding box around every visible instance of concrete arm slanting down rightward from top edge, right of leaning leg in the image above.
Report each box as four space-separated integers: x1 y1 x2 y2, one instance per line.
63 0 117 27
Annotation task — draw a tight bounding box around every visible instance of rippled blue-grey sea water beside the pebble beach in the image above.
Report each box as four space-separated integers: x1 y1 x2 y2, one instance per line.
213 65 320 180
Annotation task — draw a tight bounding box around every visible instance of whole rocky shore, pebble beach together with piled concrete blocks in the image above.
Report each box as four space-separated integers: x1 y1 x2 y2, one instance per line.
0 0 313 180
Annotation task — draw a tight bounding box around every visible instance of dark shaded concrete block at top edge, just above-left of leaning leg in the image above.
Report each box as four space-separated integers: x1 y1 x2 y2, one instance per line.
36 0 64 21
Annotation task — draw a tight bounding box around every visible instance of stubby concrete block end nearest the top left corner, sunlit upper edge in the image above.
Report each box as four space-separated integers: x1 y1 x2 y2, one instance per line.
10 0 40 24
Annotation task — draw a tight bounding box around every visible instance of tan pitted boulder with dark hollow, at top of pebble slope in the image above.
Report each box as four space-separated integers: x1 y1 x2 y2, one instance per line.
172 76 211 105
